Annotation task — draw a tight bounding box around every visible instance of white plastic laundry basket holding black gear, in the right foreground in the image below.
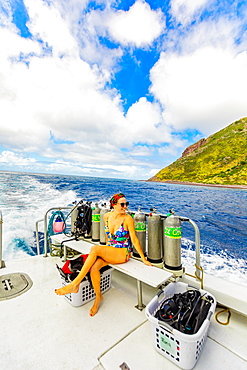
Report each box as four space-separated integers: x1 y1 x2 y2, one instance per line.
145 282 216 370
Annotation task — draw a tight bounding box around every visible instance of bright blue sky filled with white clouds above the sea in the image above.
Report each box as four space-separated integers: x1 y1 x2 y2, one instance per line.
0 0 247 179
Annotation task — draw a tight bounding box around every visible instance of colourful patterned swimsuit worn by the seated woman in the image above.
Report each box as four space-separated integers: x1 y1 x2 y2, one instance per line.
105 220 132 252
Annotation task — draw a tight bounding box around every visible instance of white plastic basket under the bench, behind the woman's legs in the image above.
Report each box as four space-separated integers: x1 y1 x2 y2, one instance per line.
62 266 113 307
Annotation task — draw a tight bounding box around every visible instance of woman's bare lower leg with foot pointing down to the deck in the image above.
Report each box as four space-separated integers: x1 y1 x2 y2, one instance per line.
90 258 108 316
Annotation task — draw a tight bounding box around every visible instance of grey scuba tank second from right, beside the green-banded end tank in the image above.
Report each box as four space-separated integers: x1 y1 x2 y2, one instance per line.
147 208 163 267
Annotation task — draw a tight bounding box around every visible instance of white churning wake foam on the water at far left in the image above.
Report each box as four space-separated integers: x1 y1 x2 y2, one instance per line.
2 175 76 260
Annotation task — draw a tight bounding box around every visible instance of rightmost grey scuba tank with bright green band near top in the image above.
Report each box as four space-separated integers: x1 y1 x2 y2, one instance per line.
163 211 183 276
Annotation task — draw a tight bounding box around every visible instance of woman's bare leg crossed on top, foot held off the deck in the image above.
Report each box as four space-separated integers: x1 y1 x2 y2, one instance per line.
55 245 126 295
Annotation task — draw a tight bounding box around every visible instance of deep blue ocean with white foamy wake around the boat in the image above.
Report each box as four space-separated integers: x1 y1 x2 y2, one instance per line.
0 172 247 285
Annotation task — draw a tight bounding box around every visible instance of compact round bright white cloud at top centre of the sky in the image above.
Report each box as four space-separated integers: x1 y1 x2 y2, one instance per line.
106 0 165 47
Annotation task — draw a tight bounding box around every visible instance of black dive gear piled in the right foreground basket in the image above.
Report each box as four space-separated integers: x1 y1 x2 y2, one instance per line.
155 289 213 334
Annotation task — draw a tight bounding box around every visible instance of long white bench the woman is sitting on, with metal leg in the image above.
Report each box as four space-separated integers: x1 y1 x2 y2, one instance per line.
51 234 173 310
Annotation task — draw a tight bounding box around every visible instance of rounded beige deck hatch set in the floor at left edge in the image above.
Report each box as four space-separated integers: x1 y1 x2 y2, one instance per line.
0 272 33 301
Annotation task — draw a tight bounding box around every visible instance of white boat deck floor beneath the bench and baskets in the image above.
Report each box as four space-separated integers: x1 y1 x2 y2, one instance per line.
0 256 247 370
